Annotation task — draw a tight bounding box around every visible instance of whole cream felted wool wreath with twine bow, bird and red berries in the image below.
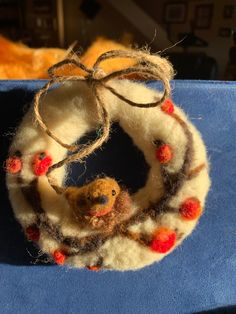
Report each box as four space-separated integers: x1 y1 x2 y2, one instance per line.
6 51 210 271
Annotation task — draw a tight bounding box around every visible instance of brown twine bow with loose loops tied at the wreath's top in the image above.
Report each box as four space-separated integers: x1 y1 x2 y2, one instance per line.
34 50 173 194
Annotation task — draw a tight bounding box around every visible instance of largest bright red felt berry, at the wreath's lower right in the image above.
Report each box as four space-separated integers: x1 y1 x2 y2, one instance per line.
150 227 176 253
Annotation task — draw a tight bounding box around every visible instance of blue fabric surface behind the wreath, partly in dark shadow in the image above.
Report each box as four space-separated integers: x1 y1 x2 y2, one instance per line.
0 81 236 314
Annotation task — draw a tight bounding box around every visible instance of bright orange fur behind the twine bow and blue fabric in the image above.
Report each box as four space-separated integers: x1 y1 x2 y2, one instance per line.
0 36 133 79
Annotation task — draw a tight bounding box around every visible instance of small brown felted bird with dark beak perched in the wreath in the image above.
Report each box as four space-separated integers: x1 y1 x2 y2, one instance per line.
65 177 131 232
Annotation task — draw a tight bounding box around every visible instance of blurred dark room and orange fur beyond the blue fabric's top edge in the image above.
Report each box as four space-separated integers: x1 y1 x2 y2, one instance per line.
0 0 236 80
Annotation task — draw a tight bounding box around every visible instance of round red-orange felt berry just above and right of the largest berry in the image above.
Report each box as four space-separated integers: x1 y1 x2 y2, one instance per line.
179 197 202 220
